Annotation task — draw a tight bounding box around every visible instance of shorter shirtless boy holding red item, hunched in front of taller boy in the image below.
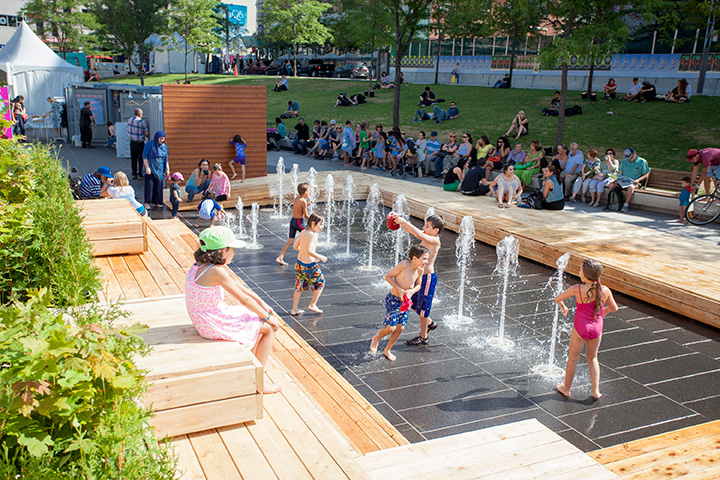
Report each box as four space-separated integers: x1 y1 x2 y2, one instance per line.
370 245 430 362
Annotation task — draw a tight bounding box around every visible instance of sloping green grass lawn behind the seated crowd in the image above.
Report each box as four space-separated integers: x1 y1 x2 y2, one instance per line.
106 74 720 171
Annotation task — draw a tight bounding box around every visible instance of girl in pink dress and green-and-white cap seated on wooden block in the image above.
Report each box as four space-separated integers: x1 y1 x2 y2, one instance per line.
185 226 280 393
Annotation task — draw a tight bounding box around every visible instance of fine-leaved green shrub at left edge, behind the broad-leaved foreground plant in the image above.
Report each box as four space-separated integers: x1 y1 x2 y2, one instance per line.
0 140 100 306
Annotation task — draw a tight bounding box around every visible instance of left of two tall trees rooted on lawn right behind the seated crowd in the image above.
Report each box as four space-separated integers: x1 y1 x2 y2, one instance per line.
379 0 432 128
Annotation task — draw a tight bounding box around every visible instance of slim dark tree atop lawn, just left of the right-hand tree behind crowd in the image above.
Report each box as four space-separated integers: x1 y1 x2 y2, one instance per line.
491 0 543 85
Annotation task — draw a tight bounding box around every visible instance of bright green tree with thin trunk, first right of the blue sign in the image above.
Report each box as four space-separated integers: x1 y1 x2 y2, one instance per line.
262 0 332 76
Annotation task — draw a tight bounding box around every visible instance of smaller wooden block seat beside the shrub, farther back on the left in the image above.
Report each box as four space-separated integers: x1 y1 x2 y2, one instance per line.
75 198 148 256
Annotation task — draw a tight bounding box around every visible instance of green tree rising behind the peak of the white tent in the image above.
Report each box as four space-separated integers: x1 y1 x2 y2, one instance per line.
22 0 91 58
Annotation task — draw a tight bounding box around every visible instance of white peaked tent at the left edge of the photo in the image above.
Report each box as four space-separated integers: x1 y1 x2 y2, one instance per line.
0 22 83 115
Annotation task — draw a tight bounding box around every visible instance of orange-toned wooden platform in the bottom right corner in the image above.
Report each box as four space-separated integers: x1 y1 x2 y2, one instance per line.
588 420 720 480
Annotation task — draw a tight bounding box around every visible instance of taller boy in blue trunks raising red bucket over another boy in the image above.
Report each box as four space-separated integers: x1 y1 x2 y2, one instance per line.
390 212 445 346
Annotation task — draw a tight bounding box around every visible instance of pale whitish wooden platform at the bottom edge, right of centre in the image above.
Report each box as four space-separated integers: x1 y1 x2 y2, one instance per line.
359 419 618 480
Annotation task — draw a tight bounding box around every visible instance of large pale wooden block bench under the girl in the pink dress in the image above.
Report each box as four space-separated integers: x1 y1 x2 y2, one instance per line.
117 295 263 438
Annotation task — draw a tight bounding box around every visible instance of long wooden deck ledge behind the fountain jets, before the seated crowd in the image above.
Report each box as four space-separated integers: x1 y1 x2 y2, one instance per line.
165 171 720 328
